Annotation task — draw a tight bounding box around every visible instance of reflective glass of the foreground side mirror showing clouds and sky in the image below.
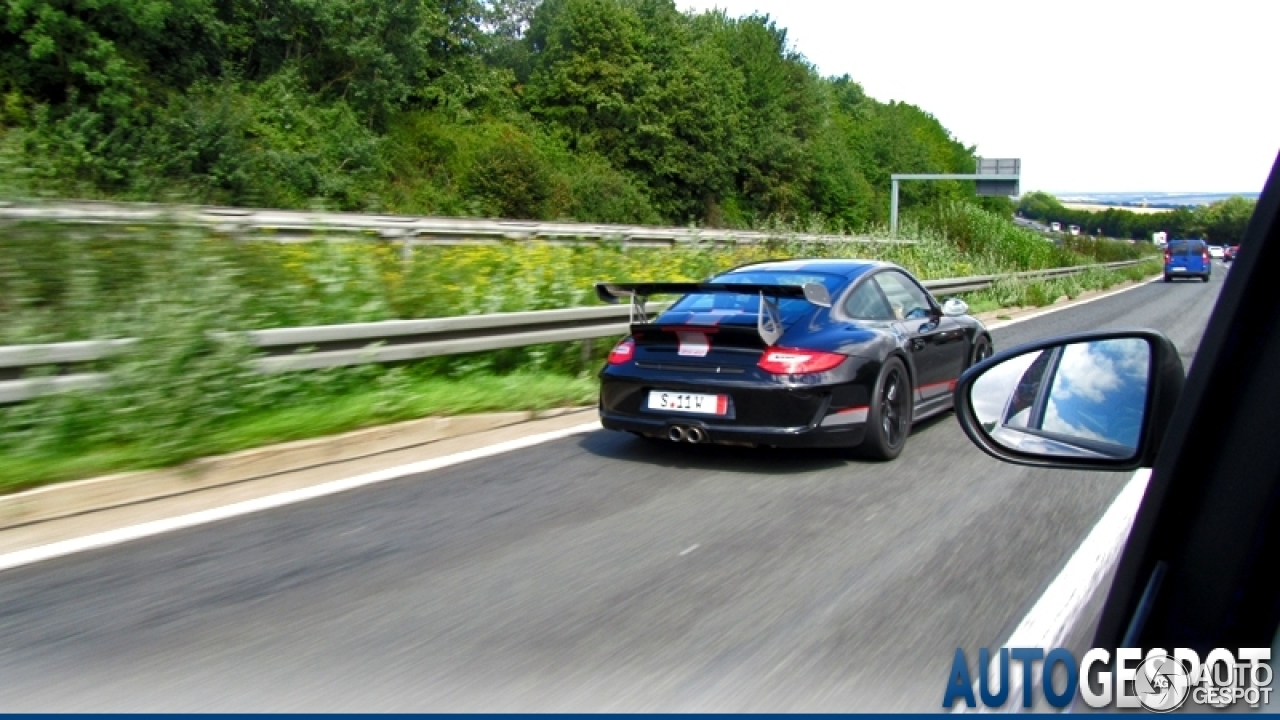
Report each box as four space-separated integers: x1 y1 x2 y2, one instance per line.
969 338 1151 460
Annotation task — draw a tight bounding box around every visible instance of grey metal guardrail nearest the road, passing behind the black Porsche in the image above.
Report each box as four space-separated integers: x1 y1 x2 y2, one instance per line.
0 260 1146 404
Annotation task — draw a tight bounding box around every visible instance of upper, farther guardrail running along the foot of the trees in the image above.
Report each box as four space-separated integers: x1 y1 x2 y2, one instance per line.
0 201 914 247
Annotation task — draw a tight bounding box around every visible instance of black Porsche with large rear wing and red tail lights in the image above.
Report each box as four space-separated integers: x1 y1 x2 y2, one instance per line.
596 260 993 460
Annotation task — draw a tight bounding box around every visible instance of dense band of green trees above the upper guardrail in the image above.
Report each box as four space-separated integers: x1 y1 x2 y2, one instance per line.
0 0 1008 234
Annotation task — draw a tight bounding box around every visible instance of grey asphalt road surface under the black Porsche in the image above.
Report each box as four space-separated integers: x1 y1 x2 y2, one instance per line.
0 265 1225 711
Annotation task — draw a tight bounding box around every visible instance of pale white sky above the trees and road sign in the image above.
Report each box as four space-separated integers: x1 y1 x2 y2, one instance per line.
677 0 1280 192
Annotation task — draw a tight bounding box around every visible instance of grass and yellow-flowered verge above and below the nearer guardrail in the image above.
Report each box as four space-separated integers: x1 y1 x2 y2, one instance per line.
0 206 1157 492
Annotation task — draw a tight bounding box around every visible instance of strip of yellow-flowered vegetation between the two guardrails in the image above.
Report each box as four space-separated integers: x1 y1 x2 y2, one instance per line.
0 202 1149 345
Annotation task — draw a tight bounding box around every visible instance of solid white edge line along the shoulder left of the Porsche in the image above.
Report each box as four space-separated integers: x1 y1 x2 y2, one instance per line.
0 421 600 571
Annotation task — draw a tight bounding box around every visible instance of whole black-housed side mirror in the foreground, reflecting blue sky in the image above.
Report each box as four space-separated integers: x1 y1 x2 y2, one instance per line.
955 331 1185 470
